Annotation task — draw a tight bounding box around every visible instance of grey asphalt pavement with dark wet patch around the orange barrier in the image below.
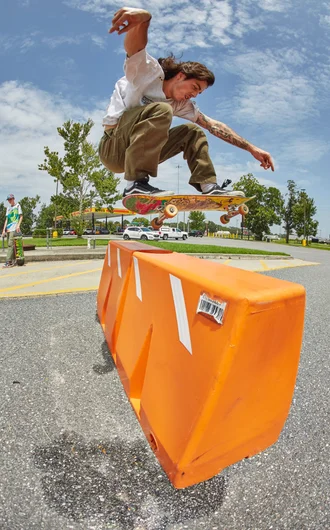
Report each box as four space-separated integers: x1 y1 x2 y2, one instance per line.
0 241 330 530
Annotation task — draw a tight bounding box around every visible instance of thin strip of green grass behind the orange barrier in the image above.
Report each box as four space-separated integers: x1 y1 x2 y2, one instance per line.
10 236 289 256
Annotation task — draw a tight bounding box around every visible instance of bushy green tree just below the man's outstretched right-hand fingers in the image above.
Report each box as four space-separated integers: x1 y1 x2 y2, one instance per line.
234 173 284 241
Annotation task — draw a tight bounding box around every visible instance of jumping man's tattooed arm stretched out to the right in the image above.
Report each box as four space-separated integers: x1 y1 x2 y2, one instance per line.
196 112 274 171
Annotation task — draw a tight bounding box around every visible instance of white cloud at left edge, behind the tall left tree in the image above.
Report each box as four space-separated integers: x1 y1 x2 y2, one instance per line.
0 81 104 201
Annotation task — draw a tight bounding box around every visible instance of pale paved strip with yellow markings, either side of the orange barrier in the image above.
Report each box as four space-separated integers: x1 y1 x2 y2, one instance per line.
0 246 318 298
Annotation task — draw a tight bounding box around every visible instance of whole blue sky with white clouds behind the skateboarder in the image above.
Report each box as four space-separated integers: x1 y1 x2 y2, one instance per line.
0 0 330 237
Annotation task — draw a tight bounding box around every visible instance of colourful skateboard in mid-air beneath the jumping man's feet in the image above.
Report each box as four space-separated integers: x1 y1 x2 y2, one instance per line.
123 195 254 230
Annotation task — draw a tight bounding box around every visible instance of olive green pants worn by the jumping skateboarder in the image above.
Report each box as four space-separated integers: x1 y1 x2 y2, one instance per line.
99 103 217 191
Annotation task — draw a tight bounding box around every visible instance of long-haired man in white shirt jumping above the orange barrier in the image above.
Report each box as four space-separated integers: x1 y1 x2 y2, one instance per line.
99 7 274 196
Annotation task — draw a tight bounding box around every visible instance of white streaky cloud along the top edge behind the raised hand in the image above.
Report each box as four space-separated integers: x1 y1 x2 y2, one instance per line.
66 0 291 52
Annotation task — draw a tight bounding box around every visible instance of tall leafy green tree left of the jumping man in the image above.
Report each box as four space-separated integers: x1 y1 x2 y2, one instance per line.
38 120 120 236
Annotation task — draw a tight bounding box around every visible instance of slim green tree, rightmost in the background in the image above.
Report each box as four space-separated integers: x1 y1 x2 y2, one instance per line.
293 191 319 244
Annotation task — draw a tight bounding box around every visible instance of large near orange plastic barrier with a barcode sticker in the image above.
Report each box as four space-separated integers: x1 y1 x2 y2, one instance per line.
110 252 305 488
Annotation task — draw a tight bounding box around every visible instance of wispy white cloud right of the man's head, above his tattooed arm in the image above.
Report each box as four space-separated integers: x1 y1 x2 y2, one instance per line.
217 49 319 129
